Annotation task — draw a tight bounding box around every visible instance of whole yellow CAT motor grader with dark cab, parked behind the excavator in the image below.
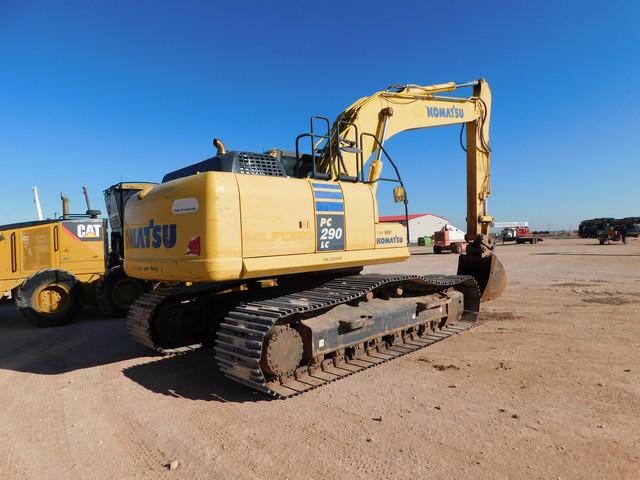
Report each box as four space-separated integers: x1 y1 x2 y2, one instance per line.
0 188 149 327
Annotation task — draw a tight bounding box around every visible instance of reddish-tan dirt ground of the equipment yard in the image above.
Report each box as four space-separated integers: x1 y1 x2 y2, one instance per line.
0 239 640 480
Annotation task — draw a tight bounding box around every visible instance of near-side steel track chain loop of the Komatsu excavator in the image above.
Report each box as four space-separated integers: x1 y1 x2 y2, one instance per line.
215 274 480 398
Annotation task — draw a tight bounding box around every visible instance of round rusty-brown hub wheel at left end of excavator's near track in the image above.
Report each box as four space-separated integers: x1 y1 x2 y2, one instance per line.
260 325 303 377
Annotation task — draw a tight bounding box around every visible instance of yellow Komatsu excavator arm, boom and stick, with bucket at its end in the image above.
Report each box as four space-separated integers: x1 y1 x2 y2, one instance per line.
319 79 506 300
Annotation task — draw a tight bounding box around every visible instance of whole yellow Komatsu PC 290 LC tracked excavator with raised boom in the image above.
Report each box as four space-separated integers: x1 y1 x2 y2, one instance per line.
124 79 506 398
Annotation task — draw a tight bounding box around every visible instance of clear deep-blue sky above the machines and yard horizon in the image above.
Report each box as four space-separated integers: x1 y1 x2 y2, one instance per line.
0 0 640 229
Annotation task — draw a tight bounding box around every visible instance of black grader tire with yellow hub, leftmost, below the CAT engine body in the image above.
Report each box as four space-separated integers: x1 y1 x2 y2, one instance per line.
15 269 83 328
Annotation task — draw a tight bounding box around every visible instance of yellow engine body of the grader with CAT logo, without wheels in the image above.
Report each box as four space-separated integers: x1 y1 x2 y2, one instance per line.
0 218 106 296
